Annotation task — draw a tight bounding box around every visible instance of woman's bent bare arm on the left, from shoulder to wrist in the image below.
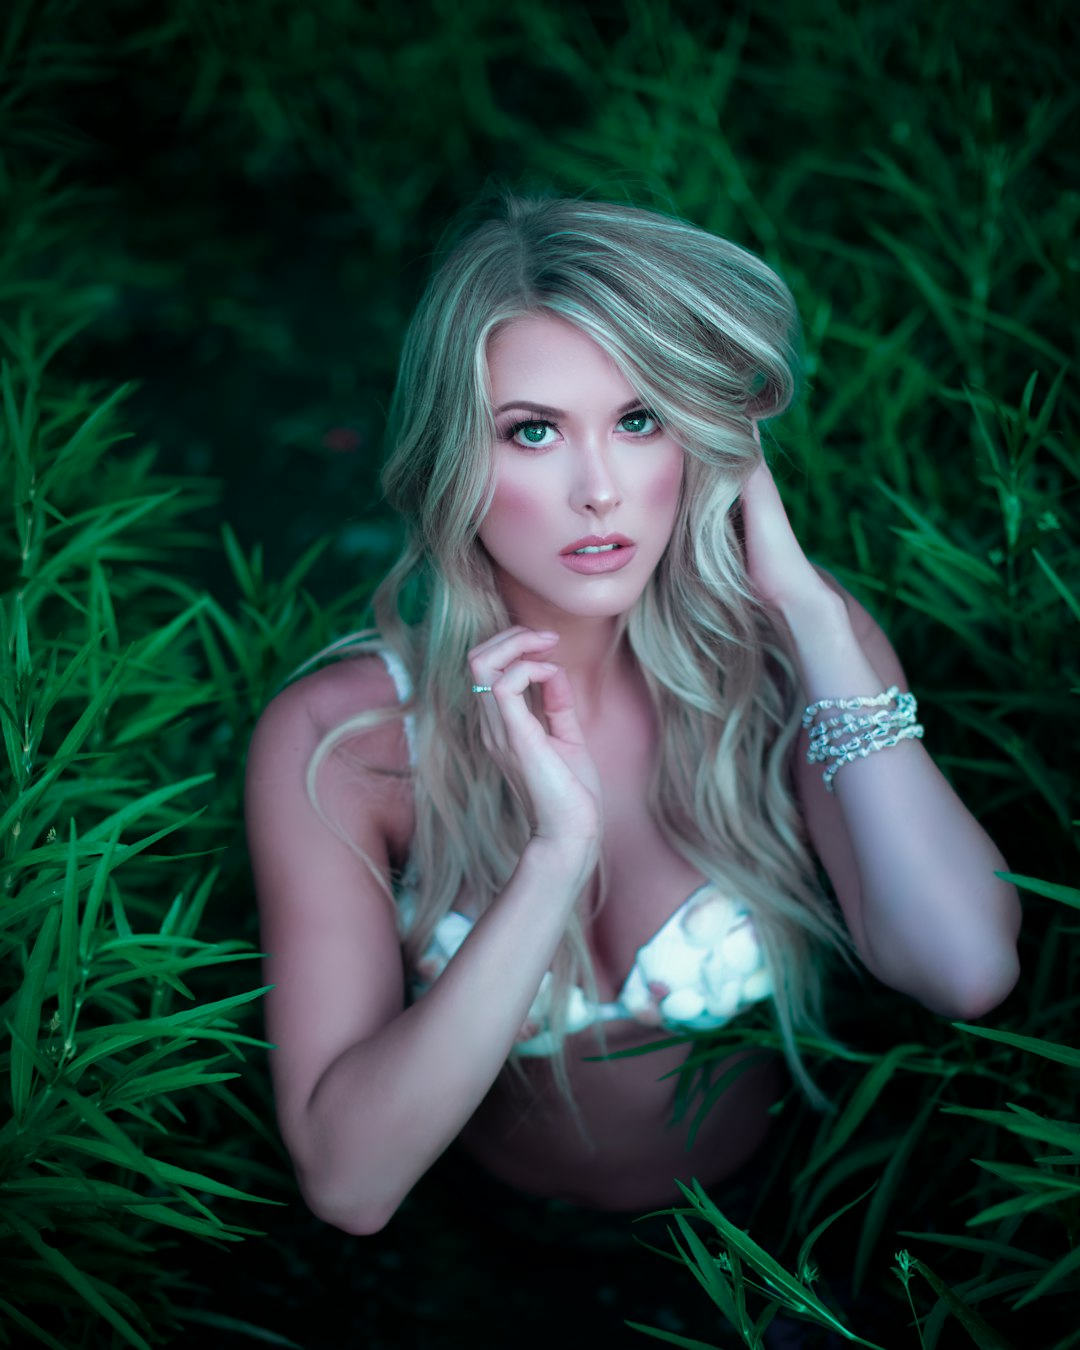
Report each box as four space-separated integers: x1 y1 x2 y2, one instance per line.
246 662 595 1234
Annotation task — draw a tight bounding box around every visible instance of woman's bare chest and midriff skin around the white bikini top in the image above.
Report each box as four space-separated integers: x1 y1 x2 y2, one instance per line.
375 656 784 1212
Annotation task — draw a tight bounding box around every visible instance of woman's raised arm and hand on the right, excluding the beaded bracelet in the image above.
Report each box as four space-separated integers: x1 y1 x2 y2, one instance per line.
743 462 1021 1018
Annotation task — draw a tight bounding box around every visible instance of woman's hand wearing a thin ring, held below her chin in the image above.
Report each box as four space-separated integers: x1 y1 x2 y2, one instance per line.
468 625 602 846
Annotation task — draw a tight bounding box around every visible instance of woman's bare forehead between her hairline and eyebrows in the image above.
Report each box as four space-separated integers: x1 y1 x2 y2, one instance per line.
487 315 630 404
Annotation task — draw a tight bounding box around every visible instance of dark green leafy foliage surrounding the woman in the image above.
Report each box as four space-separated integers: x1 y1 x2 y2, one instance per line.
0 0 1080 1350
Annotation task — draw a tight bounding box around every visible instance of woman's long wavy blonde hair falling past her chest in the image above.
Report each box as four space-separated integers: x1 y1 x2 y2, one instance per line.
301 193 848 1100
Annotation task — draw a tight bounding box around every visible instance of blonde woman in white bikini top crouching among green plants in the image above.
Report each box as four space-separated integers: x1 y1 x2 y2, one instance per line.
247 196 1019 1234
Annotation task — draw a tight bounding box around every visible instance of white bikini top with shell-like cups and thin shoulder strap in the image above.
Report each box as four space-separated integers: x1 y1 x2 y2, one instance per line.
379 649 772 1056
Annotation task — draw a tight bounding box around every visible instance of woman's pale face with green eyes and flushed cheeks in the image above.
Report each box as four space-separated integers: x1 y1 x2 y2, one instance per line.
478 315 683 624
